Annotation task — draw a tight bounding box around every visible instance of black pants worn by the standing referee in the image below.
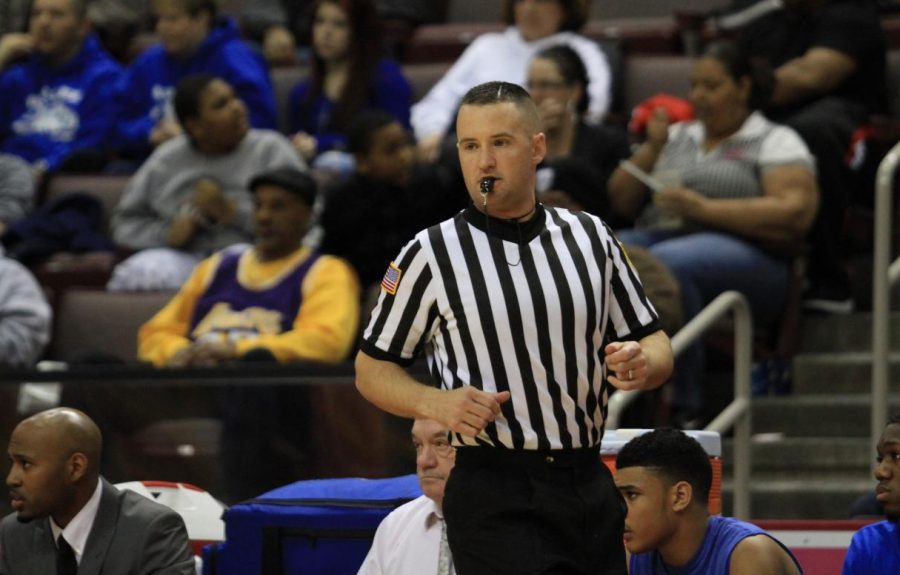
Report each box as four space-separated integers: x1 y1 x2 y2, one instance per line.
443 447 627 575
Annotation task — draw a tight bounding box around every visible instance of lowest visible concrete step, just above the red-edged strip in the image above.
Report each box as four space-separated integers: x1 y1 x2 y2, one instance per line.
722 471 875 519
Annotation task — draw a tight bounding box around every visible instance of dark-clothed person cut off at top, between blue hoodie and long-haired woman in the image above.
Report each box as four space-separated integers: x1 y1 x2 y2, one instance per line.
241 0 313 67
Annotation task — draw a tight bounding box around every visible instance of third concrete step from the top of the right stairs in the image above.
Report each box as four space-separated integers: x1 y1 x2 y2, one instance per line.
753 393 900 439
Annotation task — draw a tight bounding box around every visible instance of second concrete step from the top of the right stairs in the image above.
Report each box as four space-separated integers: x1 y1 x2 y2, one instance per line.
791 352 900 394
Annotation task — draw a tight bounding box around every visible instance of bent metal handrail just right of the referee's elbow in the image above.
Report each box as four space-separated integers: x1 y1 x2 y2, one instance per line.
606 291 753 519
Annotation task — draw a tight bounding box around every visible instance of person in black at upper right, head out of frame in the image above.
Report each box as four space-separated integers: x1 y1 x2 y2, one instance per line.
739 0 887 313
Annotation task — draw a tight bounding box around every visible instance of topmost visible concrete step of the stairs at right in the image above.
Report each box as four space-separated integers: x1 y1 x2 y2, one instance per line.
800 312 900 352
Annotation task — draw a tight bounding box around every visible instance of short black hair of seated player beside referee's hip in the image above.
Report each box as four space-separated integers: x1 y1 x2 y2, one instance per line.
616 428 712 506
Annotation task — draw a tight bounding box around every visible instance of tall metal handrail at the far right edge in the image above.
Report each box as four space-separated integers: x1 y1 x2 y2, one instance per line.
871 143 900 451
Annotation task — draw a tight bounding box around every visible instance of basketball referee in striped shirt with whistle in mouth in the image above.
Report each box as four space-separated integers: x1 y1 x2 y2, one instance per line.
356 82 672 575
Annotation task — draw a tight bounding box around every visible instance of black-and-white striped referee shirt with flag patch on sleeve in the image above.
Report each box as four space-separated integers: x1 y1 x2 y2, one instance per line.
362 204 659 450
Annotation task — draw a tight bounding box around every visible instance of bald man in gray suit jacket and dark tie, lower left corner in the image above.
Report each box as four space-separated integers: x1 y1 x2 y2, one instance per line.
0 408 195 575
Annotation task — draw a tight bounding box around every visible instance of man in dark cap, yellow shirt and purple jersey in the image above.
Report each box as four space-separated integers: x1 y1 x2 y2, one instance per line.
138 168 360 501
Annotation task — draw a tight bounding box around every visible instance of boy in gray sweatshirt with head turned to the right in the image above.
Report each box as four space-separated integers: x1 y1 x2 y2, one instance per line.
108 75 305 289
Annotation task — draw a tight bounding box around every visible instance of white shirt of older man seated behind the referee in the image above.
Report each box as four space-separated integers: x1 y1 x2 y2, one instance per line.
357 495 455 575
